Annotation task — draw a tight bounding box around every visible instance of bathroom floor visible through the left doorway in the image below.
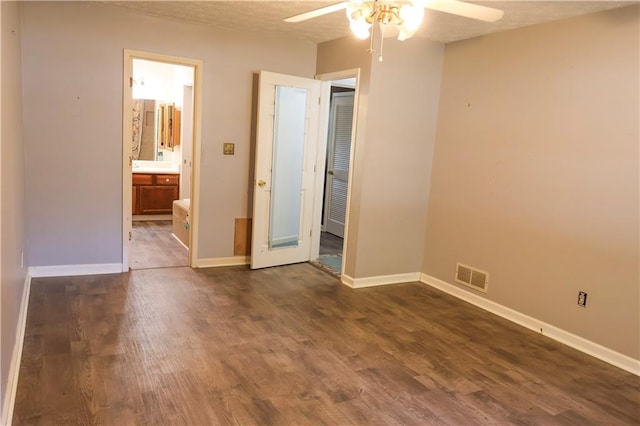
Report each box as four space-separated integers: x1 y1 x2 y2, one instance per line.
129 220 189 269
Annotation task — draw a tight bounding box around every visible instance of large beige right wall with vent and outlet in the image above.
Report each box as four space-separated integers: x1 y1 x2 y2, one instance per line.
423 6 640 359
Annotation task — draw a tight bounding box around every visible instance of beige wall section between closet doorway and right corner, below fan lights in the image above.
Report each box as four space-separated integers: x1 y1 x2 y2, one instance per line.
318 38 443 279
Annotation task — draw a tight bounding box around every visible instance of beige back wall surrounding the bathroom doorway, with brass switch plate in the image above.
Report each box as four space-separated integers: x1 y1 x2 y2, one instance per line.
23 2 316 266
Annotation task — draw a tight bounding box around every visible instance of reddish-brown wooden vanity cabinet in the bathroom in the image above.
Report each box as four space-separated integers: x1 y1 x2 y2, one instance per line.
132 173 180 215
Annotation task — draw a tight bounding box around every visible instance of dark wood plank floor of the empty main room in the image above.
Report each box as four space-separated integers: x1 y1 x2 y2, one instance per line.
14 264 640 425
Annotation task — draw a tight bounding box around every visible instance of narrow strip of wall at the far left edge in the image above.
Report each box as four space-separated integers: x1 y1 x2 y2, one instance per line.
0 1 26 420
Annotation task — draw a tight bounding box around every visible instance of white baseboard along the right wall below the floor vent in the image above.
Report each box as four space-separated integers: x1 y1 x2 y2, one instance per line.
420 274 640 376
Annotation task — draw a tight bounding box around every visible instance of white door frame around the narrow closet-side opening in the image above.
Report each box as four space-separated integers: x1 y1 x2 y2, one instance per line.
311 68 360 274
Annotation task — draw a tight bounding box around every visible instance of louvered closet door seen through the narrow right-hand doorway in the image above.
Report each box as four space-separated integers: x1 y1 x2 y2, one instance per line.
324 92 354 238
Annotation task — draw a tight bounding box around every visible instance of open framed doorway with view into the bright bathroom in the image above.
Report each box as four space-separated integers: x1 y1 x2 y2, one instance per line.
123 50 202 271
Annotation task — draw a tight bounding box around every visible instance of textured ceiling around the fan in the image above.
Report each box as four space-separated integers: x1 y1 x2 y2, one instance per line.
105 0 639 43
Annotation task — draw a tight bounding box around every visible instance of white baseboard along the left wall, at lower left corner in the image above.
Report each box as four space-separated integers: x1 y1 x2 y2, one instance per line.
0 273 31 425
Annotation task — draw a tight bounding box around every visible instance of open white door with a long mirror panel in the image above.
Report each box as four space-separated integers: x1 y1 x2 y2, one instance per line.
251 71 321 269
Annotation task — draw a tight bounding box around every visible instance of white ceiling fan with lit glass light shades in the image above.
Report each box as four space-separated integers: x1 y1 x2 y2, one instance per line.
285 0 504 40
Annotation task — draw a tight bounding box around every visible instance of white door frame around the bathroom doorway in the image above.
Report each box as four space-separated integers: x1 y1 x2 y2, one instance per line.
122 49 203 272
